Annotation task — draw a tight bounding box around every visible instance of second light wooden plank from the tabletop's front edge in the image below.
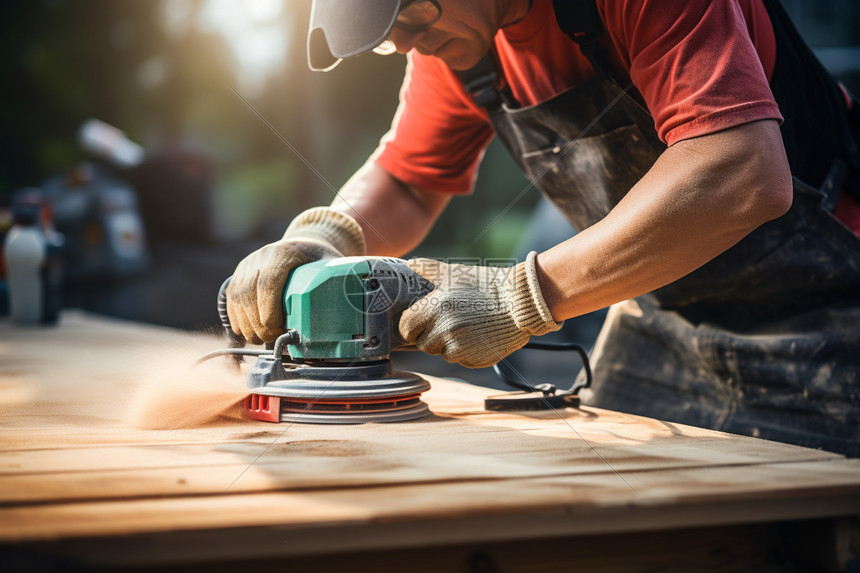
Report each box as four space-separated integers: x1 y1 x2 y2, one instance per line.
0 428 838 504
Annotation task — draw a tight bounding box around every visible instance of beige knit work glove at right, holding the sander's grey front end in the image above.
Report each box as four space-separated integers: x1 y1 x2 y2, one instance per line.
399 251 563 368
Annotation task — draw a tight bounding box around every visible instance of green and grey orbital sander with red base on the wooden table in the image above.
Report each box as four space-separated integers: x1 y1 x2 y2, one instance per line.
200 257 434 424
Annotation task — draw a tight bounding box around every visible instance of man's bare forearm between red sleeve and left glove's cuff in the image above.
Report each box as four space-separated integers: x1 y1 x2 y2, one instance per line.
331 161 449 257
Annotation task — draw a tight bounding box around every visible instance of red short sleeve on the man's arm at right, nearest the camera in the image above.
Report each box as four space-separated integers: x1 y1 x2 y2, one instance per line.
603 0 782 145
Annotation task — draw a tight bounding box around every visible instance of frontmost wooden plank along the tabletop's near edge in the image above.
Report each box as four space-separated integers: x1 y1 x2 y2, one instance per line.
0 460 860 550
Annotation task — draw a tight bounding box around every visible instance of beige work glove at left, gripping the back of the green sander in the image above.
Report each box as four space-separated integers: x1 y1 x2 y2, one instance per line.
227 207 366 344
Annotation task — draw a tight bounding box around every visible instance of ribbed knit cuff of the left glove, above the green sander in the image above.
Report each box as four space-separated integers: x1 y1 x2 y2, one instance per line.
284 207 367 257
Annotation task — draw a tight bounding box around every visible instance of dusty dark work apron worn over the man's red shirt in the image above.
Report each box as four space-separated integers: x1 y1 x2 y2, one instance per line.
461 1 860 456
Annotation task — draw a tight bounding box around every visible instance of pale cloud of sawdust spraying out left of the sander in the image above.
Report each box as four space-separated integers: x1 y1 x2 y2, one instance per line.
128 349 248 430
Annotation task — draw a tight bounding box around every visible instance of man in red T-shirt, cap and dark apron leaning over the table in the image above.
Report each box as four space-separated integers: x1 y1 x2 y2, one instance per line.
228 0 860 455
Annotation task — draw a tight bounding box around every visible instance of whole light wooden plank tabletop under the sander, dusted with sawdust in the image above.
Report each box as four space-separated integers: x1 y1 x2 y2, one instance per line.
0 312 860 565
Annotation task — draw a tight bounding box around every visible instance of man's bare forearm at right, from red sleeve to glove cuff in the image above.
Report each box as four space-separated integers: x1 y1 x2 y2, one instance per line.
538 120 792 320
